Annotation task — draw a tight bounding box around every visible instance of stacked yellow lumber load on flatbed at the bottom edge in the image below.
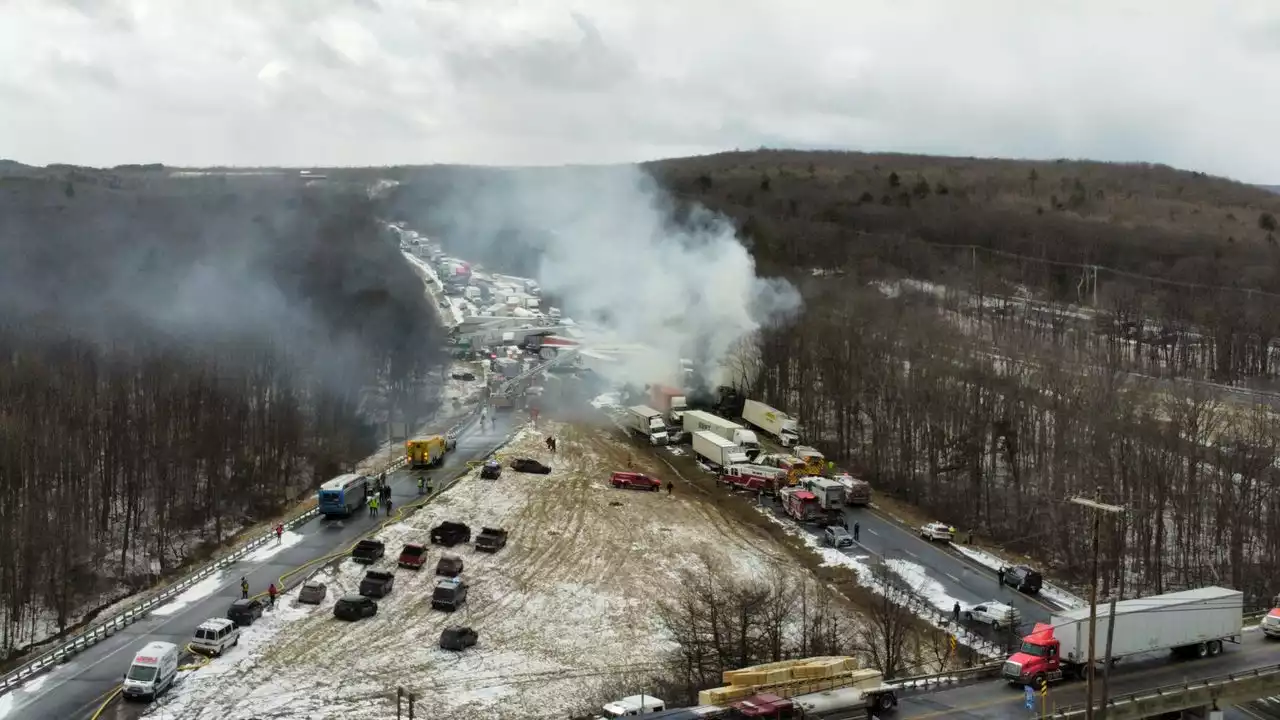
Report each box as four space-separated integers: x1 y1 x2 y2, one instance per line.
698 656 883 705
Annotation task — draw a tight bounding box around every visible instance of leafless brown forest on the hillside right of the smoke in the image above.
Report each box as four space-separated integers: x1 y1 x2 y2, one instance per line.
655 152 1280 600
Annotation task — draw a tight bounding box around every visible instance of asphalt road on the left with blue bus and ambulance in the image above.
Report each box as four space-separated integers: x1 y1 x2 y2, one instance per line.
5 414 513 720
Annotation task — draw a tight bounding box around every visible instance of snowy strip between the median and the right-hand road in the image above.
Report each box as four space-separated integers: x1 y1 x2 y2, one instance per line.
758 507 1005 659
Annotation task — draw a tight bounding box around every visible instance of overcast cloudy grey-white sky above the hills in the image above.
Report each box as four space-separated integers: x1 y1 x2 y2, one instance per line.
0 0 1280 183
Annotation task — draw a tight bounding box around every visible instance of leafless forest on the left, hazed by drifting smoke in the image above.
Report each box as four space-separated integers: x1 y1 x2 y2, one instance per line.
0 169 439 653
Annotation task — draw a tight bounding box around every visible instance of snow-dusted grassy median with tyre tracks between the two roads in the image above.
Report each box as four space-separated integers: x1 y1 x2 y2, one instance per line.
148 423 803 720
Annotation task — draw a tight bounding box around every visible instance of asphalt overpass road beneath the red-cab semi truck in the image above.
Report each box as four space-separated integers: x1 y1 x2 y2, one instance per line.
895 632 1280 720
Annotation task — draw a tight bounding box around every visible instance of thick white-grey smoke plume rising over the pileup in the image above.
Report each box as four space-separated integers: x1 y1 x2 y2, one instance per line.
397 167 800 383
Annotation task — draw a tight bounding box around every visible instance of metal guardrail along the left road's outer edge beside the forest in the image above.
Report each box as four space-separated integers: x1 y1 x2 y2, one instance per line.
0 410 479 696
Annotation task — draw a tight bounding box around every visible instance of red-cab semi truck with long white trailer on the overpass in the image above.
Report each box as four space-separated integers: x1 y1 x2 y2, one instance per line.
1001 587 1244 688
